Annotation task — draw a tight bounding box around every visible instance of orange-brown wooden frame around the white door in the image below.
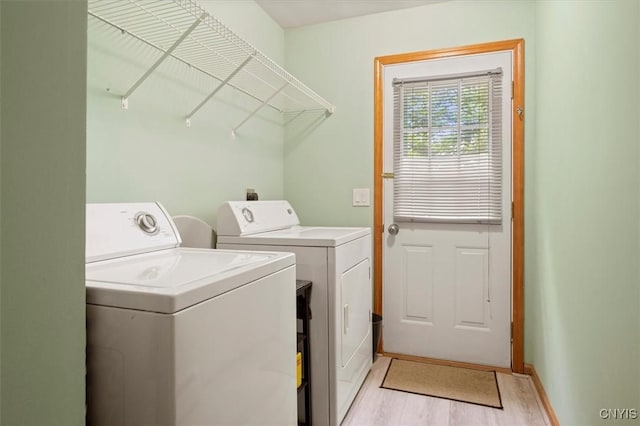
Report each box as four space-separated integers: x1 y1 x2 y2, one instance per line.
373 39 524 373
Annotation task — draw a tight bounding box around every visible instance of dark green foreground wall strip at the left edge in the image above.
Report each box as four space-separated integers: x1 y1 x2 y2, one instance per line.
0 1 86 426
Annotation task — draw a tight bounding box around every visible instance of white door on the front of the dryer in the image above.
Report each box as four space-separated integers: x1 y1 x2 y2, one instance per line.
340 258 371 368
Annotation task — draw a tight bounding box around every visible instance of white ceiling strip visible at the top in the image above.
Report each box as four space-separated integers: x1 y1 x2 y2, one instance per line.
256 0 444 28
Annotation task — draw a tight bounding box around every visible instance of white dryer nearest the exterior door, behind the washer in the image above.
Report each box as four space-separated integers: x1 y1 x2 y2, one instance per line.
217 201 372 426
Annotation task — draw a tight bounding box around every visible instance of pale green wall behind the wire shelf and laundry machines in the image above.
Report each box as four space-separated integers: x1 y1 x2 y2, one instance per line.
87 1 284 225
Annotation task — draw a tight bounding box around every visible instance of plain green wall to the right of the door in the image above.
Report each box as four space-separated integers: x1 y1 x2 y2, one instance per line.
525 1 640 425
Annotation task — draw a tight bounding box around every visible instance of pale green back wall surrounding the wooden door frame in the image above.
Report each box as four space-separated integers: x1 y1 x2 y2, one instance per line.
284 1 534 226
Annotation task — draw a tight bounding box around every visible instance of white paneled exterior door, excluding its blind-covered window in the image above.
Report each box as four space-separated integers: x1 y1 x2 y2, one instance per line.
383 51 512 367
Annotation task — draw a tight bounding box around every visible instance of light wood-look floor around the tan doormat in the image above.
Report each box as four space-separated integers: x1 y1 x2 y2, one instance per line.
342 356 550 426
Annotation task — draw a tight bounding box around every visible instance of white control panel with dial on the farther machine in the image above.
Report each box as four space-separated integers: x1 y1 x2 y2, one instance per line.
217 200 300 237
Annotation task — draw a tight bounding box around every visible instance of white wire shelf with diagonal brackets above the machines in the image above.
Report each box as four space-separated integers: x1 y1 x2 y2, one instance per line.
89 0 335 133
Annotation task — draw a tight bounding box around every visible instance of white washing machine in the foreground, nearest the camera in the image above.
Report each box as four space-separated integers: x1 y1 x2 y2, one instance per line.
86 203 297 426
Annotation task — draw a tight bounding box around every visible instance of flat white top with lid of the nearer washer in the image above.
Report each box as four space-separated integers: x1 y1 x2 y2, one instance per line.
86 248 295 313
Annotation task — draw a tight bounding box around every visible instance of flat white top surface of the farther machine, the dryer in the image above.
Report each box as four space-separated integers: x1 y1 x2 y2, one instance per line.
218 226 371 247
